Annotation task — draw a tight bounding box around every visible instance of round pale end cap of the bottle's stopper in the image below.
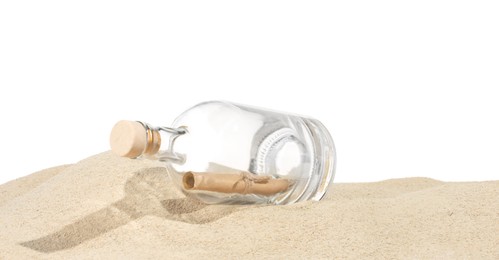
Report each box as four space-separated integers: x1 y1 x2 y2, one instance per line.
109 120 148 158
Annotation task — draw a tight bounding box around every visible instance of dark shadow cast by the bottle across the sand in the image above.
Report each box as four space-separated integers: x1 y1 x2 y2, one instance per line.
20 168 246 253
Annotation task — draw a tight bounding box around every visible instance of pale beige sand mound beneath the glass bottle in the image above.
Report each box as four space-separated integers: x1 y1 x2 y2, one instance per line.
0 152 499 259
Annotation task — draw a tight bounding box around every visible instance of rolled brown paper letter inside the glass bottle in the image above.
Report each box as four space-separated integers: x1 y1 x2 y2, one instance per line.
182 172 291 196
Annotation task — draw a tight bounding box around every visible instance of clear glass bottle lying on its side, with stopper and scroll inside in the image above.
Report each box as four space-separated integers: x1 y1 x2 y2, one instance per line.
110 101 336 205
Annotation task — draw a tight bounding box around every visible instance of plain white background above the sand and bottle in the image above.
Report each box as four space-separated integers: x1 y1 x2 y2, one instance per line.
0 0 499 183
